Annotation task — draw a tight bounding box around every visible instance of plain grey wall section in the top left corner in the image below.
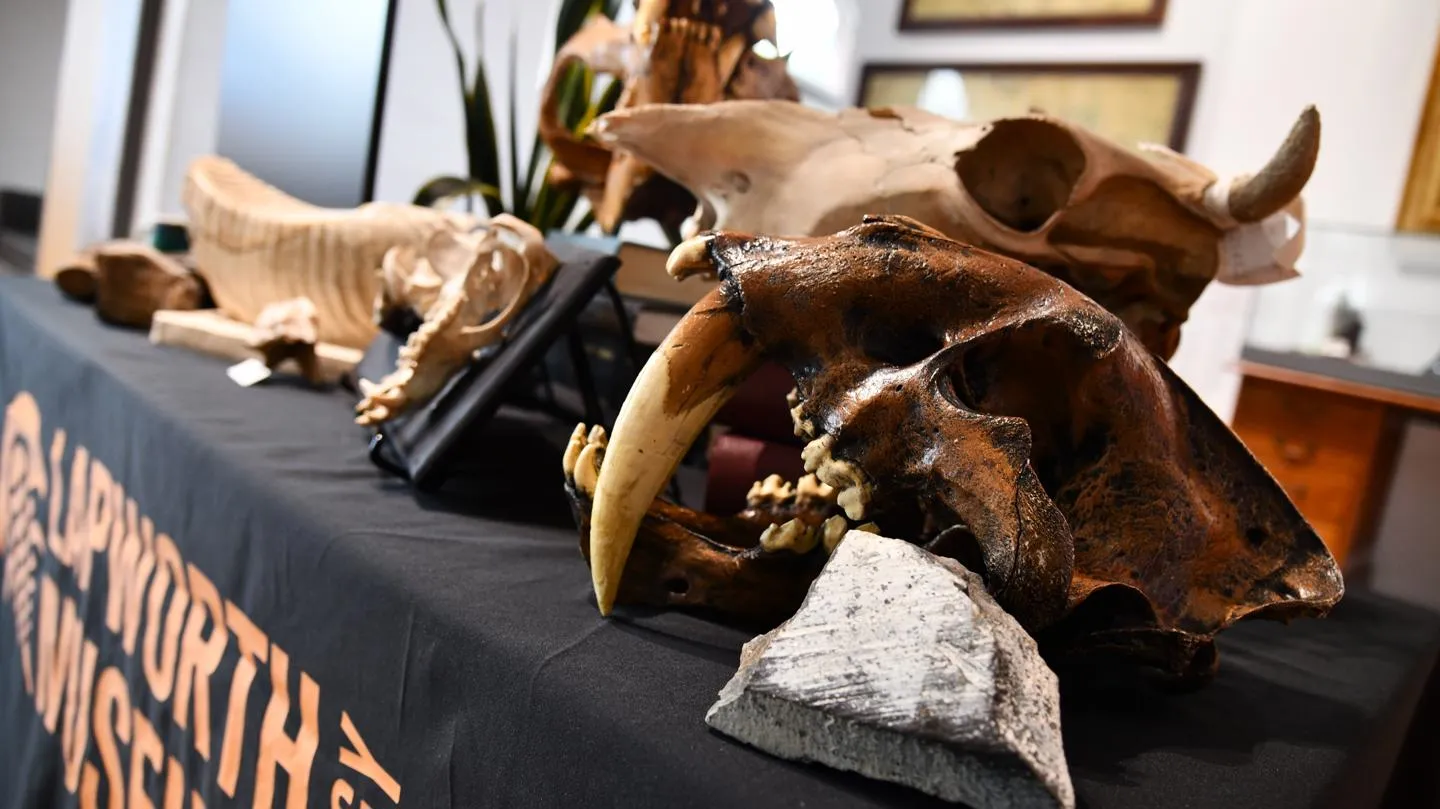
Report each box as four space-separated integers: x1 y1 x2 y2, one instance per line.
0 0 66 193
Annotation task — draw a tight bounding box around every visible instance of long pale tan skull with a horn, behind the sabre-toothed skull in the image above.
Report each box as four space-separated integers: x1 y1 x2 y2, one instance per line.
592 101 1320 357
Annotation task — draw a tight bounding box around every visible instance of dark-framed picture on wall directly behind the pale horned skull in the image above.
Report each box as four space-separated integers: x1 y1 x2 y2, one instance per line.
858 62 1200 151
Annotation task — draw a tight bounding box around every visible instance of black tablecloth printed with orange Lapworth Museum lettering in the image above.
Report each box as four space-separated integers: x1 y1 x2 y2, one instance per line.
0 278 1440 808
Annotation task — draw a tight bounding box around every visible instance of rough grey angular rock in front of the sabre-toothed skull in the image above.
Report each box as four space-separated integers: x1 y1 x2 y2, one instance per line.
706 531 1074 809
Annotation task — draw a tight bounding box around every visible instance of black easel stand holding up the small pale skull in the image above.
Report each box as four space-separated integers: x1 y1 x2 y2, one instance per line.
357 230 627 491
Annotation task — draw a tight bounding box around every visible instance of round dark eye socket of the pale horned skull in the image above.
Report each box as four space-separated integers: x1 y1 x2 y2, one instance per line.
955 118 1086 233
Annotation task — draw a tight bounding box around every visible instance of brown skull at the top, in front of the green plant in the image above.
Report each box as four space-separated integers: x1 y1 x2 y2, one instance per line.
540 0 799 232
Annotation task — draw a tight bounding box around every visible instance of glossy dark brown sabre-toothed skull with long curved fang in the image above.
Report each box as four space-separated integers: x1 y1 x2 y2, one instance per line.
564 216 1344 681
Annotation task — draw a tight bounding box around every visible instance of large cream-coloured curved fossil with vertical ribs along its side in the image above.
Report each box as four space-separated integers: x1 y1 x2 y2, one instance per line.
183 157 477 348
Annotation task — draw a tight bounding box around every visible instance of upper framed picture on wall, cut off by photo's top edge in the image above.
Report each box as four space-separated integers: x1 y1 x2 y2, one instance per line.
900 0 1166 30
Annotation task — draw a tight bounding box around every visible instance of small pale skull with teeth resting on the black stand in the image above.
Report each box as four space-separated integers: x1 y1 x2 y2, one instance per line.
356 213 557 425
